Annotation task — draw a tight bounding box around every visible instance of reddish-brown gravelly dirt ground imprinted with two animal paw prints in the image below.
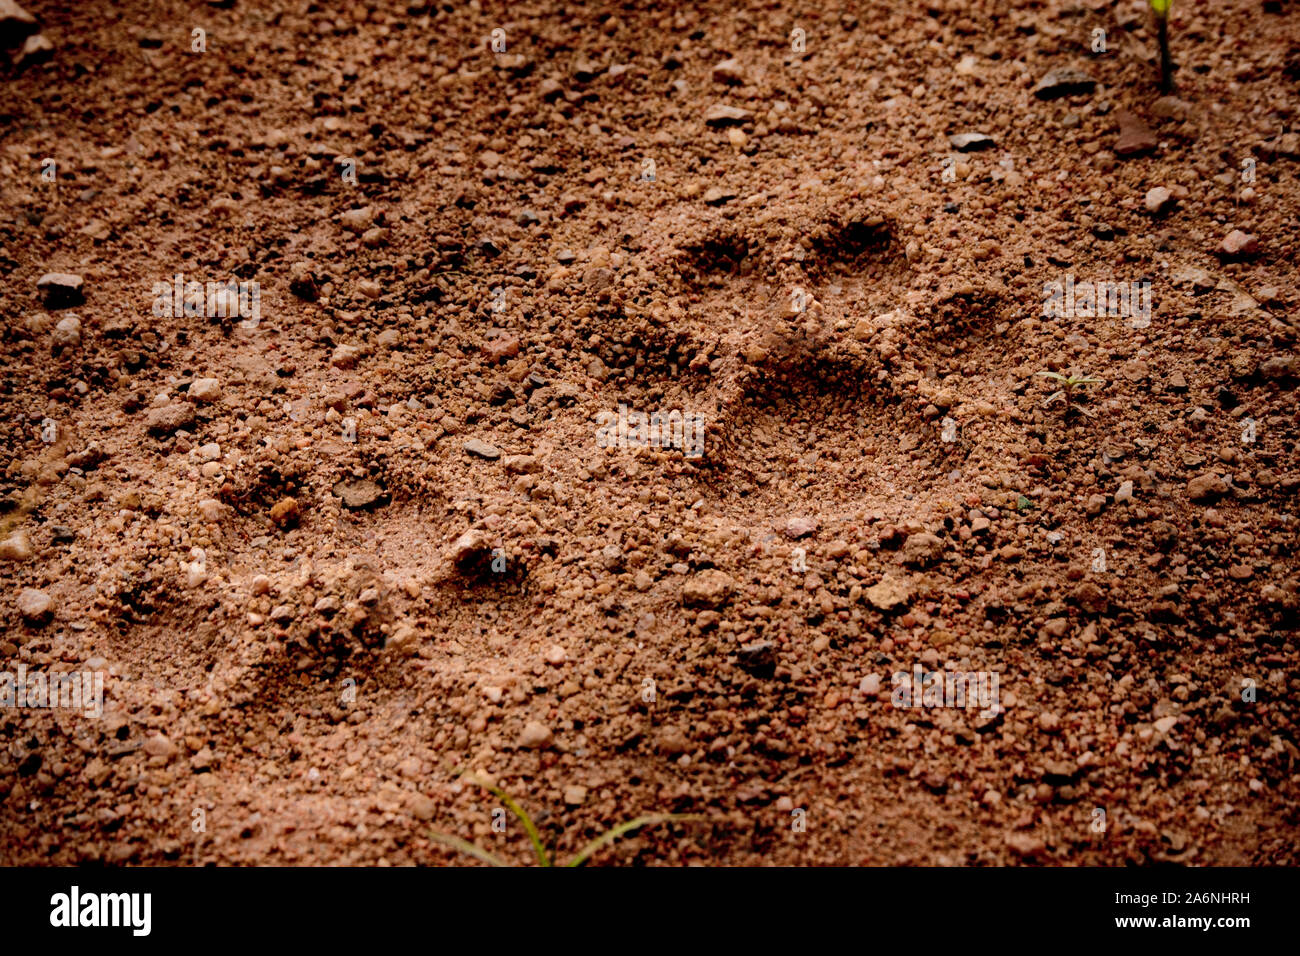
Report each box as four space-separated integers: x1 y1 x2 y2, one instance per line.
0 0 1300 865
